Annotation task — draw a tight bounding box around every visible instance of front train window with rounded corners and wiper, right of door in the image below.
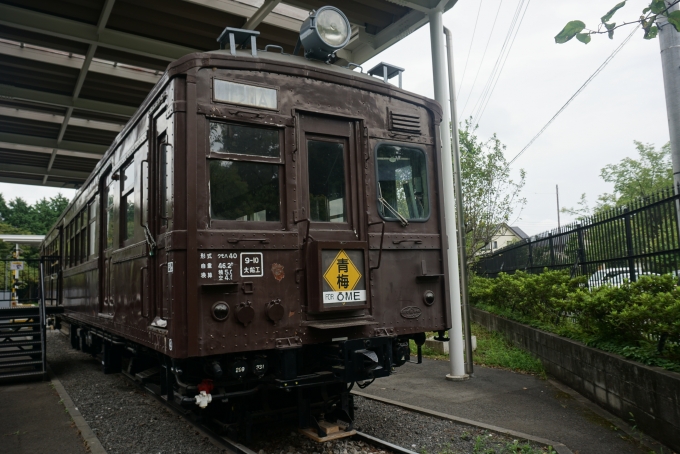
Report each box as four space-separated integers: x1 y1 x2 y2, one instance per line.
376 144 430 220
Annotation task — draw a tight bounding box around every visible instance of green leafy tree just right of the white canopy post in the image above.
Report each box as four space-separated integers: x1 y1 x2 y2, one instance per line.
460 119 526 261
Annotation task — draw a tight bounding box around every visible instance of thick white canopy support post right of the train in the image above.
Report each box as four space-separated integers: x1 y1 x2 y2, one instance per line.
430 9 469 380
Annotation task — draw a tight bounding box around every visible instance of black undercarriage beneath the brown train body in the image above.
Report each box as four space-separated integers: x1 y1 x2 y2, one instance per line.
55 315 425 441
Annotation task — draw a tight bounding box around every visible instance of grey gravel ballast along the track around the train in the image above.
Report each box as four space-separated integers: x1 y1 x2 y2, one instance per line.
47 331 540 454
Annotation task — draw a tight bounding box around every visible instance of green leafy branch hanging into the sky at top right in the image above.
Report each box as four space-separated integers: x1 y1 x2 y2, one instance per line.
555 0 680 44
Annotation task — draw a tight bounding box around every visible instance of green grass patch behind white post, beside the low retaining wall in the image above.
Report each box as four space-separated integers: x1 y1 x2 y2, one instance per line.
410 323 546 378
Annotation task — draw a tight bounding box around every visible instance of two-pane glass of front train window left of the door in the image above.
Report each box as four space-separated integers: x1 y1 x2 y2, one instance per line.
208 122 283 222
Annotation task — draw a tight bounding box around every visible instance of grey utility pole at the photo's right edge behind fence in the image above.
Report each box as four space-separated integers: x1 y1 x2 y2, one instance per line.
658 4 680 238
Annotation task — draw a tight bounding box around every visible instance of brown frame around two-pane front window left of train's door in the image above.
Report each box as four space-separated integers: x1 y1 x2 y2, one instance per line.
205 116 287 230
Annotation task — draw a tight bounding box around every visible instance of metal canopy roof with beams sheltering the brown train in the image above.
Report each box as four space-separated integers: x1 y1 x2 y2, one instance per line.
0 0 456 188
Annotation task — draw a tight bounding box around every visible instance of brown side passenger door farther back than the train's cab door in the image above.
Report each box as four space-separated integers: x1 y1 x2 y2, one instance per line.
99 169 118 317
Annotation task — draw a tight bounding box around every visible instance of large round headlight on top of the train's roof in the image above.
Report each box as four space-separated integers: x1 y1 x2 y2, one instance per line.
300 6 351 61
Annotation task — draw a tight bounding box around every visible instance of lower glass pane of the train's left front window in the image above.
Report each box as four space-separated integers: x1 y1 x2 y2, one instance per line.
208 159 281 221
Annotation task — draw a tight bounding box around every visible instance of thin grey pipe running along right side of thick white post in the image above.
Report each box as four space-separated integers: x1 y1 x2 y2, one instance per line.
444 27 474 375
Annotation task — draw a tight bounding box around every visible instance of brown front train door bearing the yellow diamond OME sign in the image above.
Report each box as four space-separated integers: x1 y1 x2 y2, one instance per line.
299 113 369 316
